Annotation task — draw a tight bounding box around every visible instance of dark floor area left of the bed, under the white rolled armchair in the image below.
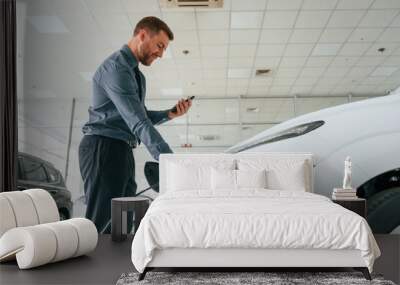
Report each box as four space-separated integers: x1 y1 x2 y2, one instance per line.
0 235 135 285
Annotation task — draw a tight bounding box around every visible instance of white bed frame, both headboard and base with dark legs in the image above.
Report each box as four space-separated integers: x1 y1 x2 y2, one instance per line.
139 153 371 280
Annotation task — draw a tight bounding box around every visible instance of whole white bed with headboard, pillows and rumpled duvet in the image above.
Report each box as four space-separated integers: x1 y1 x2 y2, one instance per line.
132 153 380 278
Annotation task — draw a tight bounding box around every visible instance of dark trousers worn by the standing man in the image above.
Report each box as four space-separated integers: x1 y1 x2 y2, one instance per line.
79 135 137 233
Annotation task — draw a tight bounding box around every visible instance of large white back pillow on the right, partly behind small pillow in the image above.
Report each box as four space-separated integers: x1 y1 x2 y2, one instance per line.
238 159 309 191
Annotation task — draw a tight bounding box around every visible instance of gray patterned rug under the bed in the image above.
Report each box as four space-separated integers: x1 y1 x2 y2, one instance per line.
117 272 395 285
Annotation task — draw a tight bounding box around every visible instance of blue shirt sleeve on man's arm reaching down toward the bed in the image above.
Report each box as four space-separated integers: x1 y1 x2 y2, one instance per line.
100 69 172 160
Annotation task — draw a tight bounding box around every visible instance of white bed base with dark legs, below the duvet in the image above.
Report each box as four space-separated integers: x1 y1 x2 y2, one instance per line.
139 248 371 280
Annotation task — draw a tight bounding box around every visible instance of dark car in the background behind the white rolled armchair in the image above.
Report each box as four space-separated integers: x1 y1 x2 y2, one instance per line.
17 152 72 220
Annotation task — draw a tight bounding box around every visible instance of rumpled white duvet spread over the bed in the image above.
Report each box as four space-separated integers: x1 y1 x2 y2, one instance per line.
132 189 380 272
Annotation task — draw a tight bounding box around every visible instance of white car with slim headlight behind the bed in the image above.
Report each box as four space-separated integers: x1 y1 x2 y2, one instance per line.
226 88 400 233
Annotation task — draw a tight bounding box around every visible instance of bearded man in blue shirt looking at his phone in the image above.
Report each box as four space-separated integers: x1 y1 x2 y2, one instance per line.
79 17 191 233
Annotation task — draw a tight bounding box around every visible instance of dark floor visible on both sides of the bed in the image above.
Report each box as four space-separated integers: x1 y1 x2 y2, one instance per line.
0 235 400 285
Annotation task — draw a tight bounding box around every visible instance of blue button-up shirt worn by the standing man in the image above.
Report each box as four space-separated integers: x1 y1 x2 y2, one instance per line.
82 45 172 160
